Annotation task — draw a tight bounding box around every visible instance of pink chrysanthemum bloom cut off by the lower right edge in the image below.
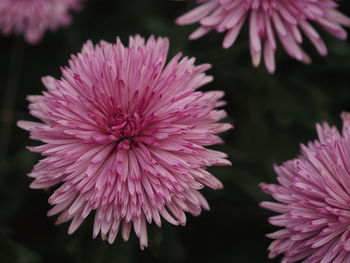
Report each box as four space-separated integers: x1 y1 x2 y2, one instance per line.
261 113 350 263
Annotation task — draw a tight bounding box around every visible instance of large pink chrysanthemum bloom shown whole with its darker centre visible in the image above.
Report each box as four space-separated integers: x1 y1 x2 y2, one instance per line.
18 36 232 248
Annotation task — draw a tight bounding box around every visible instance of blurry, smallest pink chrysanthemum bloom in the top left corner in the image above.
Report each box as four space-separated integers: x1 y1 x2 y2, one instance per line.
0 0 83 44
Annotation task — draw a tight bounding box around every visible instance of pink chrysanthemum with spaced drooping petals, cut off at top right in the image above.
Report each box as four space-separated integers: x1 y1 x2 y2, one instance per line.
176 0 350 73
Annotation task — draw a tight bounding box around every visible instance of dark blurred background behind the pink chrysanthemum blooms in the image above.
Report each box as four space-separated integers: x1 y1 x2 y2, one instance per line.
0 0 350 263
